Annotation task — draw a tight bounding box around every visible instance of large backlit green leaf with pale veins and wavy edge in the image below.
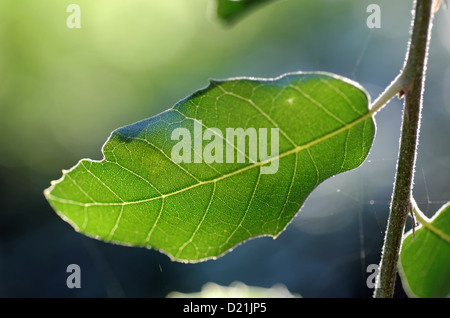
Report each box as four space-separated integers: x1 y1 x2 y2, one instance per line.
45 73 375 262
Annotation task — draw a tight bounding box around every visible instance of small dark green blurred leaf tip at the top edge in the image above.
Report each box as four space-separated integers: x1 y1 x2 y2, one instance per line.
217 0 276 23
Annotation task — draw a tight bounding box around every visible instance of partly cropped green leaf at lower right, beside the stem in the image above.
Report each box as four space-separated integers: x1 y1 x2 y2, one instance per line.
399 202 450 298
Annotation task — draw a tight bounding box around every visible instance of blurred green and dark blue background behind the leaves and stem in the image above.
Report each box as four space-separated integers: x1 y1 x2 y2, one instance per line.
0 0 450 297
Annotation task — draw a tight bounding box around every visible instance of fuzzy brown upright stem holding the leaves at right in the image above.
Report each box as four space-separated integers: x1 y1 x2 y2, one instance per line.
375 0 433 298
